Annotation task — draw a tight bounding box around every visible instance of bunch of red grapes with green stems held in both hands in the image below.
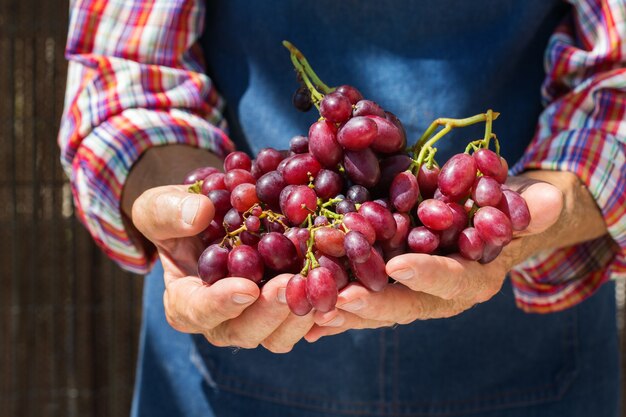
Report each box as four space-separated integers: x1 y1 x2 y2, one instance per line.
185 44 530 315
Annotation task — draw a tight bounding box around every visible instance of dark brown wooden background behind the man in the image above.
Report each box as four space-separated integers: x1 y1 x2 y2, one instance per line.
0 0 624 417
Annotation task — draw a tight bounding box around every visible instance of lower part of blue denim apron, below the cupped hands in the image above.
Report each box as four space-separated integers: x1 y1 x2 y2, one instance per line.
132 265 620 417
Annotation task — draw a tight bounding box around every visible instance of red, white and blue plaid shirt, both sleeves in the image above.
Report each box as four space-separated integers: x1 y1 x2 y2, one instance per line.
59 0 626 312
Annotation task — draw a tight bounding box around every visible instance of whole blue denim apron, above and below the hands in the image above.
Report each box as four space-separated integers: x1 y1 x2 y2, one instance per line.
133 0 619 417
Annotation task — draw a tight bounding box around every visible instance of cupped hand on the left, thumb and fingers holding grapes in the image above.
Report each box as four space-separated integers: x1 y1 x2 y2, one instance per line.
132 186 313 353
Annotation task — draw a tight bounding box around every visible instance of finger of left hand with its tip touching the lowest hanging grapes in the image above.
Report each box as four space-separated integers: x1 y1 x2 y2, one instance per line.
205 274 292 349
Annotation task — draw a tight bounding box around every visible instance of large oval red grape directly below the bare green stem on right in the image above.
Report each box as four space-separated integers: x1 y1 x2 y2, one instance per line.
438 153 476 200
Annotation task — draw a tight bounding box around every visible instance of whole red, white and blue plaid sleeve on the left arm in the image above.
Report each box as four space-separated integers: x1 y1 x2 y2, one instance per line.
58 0 233 274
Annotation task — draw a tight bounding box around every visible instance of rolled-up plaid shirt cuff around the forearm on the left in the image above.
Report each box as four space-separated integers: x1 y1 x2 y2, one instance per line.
70 109 234 274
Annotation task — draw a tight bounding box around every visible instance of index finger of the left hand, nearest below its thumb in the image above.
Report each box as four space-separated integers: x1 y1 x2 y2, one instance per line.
163 276 260 333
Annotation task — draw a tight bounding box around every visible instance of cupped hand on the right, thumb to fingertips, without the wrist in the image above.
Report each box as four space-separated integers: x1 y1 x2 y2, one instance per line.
305 177 564 342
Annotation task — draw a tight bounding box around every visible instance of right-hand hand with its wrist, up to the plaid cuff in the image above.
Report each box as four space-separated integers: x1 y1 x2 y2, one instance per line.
306 171 606 341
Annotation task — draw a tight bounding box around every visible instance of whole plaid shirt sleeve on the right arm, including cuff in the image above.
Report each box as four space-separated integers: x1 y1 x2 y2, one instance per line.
511 0 626 313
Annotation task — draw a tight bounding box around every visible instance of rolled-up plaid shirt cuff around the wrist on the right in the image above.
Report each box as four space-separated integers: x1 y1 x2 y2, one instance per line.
511 129 626 313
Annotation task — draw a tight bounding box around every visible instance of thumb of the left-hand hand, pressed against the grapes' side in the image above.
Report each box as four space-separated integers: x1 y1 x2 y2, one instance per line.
132 185 215 242
